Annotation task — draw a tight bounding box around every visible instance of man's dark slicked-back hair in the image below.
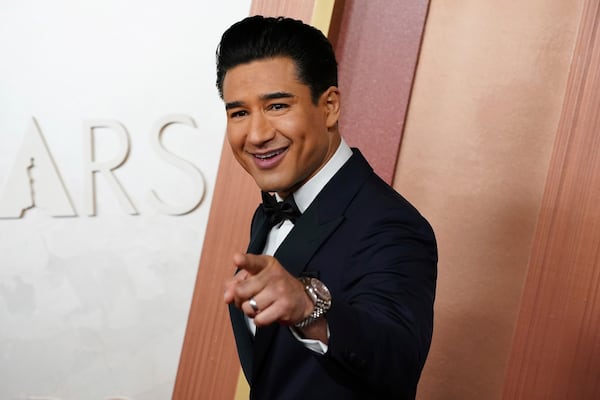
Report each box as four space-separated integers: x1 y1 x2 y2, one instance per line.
217 15 338 104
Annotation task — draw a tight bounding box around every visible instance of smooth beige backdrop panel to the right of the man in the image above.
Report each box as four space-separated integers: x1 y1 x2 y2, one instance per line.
394 0 583 399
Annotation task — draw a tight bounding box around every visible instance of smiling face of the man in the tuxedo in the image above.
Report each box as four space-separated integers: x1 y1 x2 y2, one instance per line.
223 57 340 198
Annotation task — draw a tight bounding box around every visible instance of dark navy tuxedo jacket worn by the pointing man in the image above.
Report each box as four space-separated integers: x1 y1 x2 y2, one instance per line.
230 149 437 400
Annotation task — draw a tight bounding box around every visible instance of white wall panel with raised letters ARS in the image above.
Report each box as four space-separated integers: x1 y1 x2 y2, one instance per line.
0 0 250 400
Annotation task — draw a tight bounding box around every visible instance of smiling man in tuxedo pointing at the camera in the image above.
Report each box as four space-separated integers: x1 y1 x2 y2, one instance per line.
217 16 437 400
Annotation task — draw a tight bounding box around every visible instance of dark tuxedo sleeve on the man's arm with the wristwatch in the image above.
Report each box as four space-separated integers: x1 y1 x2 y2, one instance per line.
320 208 437 399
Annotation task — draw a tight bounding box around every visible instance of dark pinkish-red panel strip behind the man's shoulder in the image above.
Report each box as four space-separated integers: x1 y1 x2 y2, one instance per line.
334 0 429 184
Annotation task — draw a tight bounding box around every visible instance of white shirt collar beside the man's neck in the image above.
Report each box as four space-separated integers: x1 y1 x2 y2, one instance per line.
277 139 352 213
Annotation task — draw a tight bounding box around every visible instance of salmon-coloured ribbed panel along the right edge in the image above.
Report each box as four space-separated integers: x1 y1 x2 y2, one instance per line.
504 0 600 400
